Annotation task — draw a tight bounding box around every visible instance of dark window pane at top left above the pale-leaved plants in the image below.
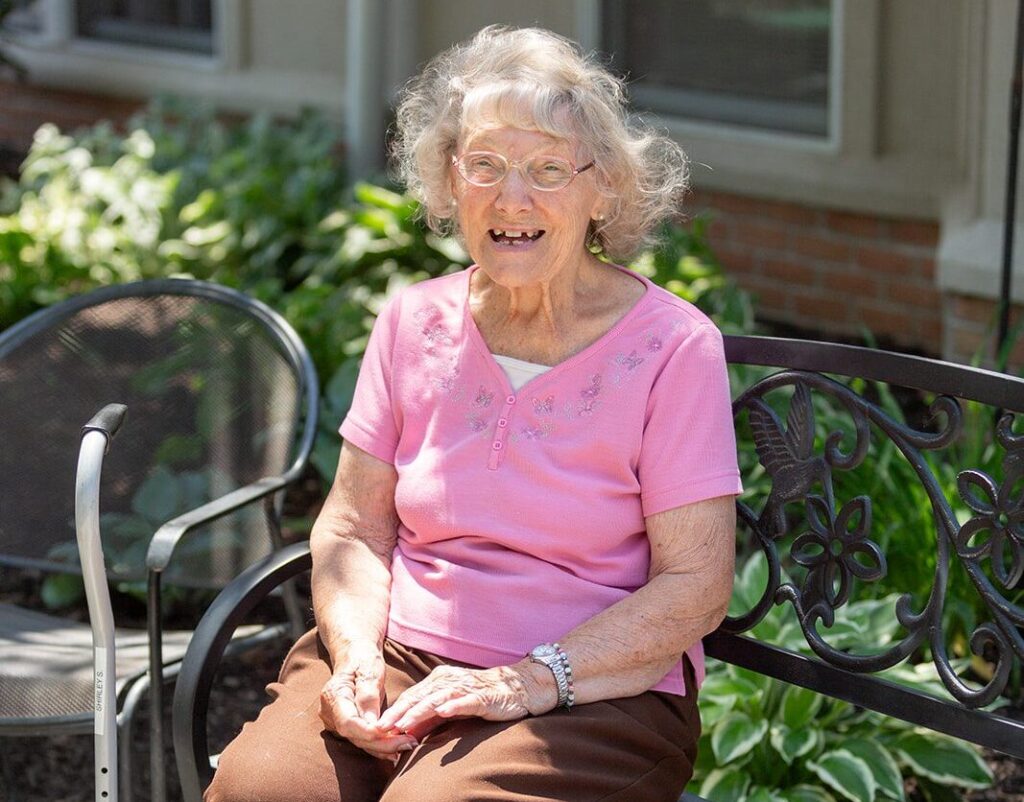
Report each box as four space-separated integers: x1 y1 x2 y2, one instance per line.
75 0 213 55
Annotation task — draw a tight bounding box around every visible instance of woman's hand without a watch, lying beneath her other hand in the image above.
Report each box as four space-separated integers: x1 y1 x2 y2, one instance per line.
319 643 416 762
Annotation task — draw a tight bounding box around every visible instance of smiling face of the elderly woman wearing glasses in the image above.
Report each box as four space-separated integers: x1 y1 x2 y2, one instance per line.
452 127 606 289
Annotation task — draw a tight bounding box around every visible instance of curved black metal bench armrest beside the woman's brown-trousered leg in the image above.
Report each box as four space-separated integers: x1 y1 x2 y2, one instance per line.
172 543 312 802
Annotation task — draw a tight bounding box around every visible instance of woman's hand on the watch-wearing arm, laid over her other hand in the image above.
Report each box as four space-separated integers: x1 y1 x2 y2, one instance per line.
379 661 558 737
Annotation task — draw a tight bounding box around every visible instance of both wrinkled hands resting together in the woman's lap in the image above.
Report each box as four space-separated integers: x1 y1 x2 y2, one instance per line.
319 647 556 762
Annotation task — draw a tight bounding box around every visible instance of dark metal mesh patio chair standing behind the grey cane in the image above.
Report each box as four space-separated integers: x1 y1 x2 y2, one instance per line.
0 280 317 800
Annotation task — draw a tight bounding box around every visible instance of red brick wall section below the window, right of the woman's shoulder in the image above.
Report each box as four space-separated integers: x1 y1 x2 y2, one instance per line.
688 192 942 353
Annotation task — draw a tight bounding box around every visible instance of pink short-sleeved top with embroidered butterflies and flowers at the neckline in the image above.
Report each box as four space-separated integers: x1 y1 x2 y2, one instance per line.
341 267 740 693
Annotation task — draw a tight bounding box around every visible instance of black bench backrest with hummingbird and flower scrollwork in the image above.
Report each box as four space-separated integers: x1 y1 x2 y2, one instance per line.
706 337 1024 758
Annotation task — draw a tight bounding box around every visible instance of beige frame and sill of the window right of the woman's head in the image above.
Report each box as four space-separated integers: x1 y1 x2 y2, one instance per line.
573 0 948 218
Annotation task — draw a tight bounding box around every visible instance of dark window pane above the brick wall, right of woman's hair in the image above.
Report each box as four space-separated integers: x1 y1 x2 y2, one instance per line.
602 0 834 137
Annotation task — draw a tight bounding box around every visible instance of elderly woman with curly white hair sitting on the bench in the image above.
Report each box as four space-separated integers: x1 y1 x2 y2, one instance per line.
207 28 739 802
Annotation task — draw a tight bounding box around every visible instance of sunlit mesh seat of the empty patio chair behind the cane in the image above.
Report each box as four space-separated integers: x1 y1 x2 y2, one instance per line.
0 603 191 731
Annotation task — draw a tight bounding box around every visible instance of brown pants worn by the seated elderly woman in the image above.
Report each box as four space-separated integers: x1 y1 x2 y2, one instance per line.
205 630 700 802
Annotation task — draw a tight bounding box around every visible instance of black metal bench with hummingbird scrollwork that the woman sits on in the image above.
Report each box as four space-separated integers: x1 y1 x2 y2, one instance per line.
173 336 1024 802
